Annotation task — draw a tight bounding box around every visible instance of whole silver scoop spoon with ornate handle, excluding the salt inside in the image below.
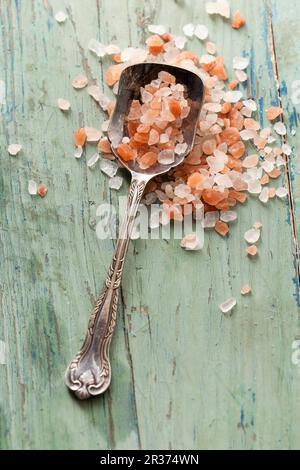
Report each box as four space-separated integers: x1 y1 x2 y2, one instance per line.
65 63 204 400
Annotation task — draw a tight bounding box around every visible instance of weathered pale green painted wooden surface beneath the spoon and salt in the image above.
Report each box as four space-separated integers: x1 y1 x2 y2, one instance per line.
0 0 300 449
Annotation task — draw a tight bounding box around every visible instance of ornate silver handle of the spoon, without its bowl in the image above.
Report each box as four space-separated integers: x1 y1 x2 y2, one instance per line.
65 174 150 400
